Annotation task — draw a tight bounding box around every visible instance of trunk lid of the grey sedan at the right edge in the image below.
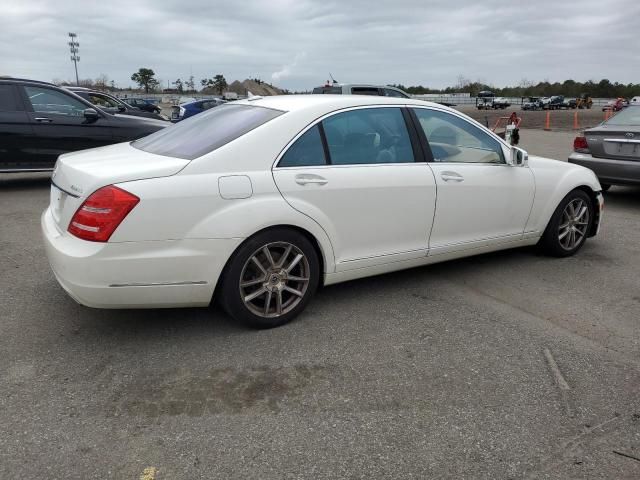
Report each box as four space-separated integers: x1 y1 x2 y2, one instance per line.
585 125 640 161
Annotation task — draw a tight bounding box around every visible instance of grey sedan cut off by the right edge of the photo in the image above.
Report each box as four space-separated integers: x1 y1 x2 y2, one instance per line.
569 105 640 190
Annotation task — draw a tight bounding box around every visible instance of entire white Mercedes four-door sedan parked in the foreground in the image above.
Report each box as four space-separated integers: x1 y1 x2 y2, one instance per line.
42 95 603 328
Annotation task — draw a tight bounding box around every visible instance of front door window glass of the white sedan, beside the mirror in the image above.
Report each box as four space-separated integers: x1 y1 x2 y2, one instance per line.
414 108 505 163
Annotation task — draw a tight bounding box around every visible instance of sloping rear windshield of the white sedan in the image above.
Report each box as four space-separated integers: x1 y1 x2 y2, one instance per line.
131 104 284 160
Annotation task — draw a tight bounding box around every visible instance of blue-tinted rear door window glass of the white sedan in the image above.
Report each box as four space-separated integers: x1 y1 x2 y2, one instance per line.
322 108 415 165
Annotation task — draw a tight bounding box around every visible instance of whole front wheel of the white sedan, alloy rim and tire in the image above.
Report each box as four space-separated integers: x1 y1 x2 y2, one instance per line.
541 190 593 257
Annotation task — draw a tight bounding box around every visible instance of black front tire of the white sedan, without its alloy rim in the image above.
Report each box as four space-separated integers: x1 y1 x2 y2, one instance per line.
538 190 594 257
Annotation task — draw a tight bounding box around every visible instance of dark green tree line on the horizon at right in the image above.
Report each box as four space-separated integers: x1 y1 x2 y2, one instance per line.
391 77 640 98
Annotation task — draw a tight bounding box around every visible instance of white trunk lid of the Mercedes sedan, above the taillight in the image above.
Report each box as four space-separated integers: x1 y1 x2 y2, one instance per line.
50 143 189 231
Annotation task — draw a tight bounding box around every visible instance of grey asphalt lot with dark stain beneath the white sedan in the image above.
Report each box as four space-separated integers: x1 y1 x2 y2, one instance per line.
0 141 640 480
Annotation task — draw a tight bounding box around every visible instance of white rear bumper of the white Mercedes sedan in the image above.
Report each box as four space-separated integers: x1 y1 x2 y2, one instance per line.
41 209 241 308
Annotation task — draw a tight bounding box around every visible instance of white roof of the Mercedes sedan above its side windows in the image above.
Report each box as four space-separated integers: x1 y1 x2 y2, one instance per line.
233 94 438 112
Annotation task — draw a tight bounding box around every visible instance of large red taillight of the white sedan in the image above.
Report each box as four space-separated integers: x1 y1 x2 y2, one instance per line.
68 185 140 242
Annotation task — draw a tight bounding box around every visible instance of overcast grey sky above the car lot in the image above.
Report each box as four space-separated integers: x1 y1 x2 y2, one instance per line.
0 0 640 90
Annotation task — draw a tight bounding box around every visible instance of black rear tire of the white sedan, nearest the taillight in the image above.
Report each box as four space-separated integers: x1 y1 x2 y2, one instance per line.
218 228 320 329
